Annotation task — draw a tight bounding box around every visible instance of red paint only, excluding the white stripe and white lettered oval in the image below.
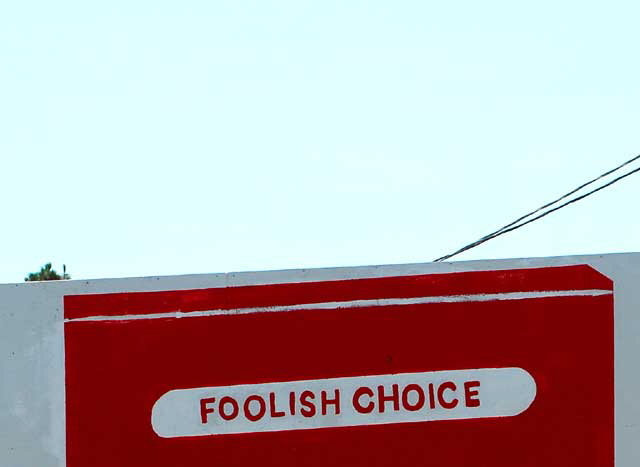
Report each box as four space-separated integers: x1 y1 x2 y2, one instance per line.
65 266 614 467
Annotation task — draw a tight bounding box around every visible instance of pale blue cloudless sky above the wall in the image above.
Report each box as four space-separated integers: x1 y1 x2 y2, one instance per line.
0 0 640 282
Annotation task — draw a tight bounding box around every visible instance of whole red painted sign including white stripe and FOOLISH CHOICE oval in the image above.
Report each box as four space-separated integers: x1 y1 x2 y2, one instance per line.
65 266 614 467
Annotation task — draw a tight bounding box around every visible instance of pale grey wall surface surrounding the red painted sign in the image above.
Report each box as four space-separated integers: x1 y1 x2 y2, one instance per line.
0 253 640 467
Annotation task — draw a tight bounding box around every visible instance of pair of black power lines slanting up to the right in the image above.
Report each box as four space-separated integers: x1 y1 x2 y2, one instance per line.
434 155 640 262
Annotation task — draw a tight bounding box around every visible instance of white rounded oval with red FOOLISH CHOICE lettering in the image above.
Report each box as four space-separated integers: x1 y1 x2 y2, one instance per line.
151 368 536 438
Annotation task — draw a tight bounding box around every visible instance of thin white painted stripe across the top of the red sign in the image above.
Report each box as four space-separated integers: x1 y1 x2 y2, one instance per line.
65 289 613 322
